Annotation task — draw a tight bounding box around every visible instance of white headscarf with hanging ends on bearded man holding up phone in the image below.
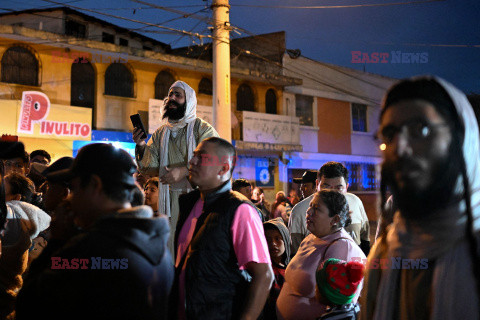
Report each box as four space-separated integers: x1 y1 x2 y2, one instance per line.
158 81 197 217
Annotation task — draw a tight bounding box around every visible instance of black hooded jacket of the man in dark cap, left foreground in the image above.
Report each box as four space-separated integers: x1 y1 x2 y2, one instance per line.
17 206 173 320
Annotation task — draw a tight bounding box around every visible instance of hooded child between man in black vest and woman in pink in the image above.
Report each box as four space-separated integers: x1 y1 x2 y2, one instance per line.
263 217 291 319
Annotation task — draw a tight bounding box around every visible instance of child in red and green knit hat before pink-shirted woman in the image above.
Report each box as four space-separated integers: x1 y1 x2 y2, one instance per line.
316 258 365 320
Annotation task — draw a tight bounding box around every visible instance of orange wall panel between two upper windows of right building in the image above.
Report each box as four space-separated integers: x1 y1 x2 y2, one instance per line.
317 98 352 154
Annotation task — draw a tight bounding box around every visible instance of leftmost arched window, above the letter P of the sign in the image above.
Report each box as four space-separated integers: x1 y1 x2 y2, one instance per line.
2 47 38 86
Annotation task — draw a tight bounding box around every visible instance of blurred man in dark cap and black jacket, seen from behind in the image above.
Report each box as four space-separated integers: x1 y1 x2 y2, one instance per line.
17 143 173 320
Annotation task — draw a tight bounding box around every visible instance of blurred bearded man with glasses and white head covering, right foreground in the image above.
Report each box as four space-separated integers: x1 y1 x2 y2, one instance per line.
362 77 480 320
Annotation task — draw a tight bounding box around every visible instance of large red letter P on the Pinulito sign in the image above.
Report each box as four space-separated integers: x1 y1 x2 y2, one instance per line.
18 91 50 134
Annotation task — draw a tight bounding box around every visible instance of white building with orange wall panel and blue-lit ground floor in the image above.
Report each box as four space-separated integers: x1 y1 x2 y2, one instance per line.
280 54 396 220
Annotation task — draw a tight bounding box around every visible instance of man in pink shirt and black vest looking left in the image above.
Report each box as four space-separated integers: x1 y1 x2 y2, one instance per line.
169 137 273 319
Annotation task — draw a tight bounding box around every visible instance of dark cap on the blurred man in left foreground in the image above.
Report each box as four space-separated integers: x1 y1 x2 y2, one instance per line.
47 143 137 186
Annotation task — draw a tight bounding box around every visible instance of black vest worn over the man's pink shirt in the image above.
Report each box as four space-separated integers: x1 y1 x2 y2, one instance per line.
175 183 253 319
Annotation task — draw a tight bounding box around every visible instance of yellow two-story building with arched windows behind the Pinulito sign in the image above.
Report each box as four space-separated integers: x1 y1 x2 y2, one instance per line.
0 7 301 199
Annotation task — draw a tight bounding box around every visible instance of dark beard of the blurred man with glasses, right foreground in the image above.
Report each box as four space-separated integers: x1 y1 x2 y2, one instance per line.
382 151 460 219
